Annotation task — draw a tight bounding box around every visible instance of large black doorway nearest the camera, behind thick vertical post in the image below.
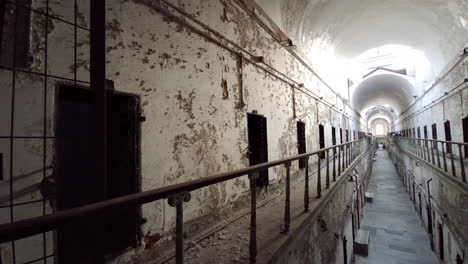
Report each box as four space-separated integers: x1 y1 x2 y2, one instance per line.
55 85 141 263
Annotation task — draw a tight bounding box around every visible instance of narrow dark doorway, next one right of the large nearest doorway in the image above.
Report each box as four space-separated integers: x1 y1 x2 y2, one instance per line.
247 114 268 187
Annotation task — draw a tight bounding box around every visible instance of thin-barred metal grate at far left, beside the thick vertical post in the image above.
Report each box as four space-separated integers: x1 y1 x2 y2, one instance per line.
0 0 90 264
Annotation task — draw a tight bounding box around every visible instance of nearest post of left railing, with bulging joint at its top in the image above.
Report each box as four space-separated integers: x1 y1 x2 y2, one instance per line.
167 193 191 264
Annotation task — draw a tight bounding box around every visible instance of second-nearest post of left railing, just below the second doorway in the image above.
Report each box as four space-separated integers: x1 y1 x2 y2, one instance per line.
249 172 258 264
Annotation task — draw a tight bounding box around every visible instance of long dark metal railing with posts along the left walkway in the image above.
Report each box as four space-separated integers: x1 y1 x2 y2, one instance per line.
0 137 371 263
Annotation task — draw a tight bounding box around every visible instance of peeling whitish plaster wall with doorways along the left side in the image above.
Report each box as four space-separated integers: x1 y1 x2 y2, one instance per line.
0 0 370 263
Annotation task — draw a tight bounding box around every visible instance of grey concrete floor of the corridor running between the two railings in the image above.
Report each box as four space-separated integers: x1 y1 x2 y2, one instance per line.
355 149 439 264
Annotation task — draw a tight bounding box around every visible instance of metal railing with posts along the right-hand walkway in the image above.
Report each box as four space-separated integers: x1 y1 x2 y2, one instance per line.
393 136 468 183
